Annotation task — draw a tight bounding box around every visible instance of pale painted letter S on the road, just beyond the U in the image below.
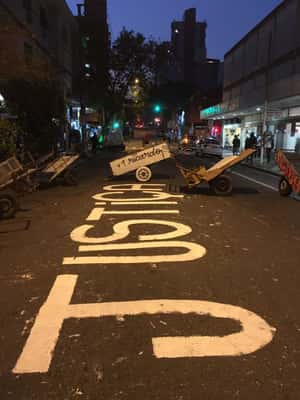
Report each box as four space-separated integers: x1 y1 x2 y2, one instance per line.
71 219 192 244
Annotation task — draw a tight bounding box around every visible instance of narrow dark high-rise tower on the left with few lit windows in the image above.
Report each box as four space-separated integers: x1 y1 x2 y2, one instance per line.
77 0 110 109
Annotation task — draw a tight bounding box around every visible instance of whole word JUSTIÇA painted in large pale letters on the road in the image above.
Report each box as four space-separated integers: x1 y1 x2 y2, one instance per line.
13 184 275 374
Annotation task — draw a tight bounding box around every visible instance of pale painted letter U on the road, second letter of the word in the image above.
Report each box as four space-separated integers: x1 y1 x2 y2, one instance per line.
63 240 206 265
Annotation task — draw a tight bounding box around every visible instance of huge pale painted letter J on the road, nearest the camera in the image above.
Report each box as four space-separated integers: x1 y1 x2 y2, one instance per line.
13 275 275 374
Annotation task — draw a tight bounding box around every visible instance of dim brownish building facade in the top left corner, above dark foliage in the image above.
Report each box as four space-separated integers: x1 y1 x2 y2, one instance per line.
0 0 78 99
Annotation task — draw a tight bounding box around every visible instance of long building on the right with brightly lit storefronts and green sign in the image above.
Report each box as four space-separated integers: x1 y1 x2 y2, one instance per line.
201 0 300 150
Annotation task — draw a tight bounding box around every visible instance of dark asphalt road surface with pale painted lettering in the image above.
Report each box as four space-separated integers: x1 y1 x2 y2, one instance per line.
0 152 300 400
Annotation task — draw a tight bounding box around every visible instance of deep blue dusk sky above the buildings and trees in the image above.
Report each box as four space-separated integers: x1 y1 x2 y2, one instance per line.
67 0 282 58
